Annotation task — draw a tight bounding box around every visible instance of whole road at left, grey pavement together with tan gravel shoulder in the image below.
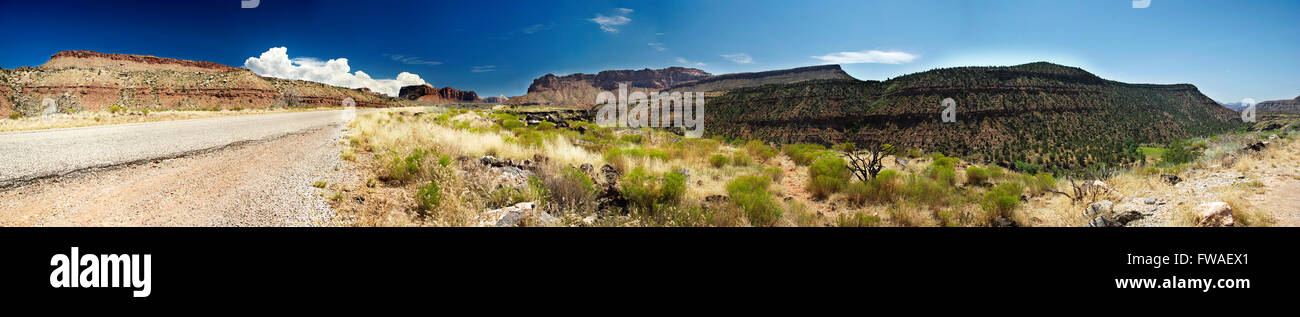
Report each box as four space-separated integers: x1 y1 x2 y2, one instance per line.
0 110 368 226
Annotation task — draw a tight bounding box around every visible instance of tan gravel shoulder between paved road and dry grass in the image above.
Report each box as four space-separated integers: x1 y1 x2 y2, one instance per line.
0 125 360 226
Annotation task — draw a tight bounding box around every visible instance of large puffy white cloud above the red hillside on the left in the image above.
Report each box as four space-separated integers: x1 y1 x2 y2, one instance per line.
244 47 425 96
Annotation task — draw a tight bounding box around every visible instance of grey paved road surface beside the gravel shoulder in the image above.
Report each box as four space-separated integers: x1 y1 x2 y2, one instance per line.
0 109 373 188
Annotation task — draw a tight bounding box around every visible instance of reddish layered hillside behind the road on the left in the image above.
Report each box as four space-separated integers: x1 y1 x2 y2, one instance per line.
0 51 399 116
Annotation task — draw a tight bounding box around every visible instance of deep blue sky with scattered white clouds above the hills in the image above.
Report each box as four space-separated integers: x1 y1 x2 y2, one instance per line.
0 0 1300 101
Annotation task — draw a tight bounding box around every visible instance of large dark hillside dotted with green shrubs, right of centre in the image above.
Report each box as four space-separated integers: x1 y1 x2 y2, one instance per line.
705 62 1240 169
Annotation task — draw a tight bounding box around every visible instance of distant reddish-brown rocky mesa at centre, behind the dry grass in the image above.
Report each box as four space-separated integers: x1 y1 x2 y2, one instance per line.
508 68 711 108
